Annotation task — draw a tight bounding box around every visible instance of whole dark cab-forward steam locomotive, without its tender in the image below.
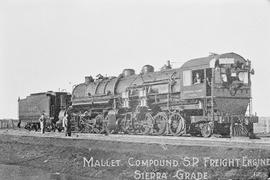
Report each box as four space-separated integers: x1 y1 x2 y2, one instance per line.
71 53 258 137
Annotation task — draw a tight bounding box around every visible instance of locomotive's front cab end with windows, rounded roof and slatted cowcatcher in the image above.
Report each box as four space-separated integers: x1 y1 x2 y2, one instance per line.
181 53 257 136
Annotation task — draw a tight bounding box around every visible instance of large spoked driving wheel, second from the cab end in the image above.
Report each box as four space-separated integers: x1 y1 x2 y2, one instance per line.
153 112 168 135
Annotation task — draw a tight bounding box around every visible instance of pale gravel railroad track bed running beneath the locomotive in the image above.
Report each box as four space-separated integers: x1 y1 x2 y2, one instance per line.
0 129 270 149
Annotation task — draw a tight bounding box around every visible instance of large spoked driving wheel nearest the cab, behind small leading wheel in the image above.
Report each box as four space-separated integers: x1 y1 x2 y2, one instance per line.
169 113 185 136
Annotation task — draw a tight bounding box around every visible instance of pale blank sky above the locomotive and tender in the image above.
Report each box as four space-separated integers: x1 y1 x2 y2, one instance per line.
0 0 270 118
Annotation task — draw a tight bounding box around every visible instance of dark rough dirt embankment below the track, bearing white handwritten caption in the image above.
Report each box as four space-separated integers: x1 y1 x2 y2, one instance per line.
0 130 270 180
